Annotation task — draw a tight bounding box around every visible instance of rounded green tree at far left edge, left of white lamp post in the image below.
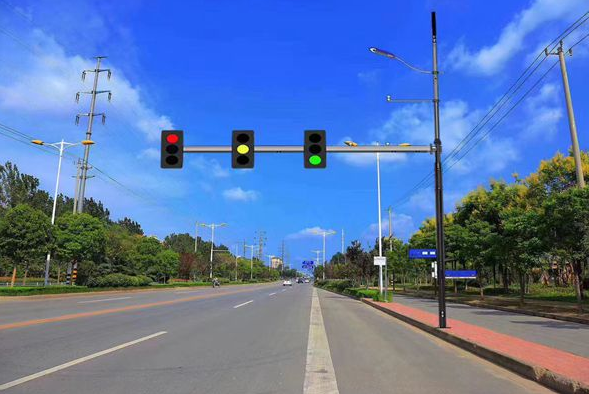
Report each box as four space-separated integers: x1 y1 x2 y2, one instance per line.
0 204 51 284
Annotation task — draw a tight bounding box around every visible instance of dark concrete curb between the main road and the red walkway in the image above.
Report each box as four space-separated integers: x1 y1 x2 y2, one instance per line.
361 298 589 394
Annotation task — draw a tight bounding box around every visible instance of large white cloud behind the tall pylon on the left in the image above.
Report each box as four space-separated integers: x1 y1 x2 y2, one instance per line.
0 29 174 141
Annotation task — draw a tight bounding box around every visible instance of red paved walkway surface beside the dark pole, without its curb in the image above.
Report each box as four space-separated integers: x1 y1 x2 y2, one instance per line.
368 298 589 386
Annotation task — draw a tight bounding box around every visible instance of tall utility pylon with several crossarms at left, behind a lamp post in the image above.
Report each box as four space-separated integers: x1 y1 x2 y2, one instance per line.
76 56 112 213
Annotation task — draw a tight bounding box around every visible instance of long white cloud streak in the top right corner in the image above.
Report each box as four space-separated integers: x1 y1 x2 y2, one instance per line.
448 0 587 75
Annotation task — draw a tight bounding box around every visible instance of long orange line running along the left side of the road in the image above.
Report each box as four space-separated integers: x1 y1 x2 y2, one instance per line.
0 287 260 331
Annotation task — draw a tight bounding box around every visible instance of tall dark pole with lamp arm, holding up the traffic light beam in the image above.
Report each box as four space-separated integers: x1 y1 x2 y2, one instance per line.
369 12 446 328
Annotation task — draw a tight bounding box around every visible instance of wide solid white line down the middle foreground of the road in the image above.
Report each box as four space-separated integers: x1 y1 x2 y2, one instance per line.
303 288 339 394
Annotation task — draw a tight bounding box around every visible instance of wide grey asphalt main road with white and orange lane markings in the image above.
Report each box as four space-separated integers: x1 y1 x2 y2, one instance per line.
0 284 549 394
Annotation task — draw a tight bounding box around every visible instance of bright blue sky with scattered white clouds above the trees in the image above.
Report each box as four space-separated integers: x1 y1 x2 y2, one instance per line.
0 0 589 266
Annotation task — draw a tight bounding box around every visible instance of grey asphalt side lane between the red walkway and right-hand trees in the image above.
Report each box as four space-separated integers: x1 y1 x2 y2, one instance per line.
394 294 589 357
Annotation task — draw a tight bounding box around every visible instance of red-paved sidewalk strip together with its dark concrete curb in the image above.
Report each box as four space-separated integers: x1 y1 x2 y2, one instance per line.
362 297 589 394
